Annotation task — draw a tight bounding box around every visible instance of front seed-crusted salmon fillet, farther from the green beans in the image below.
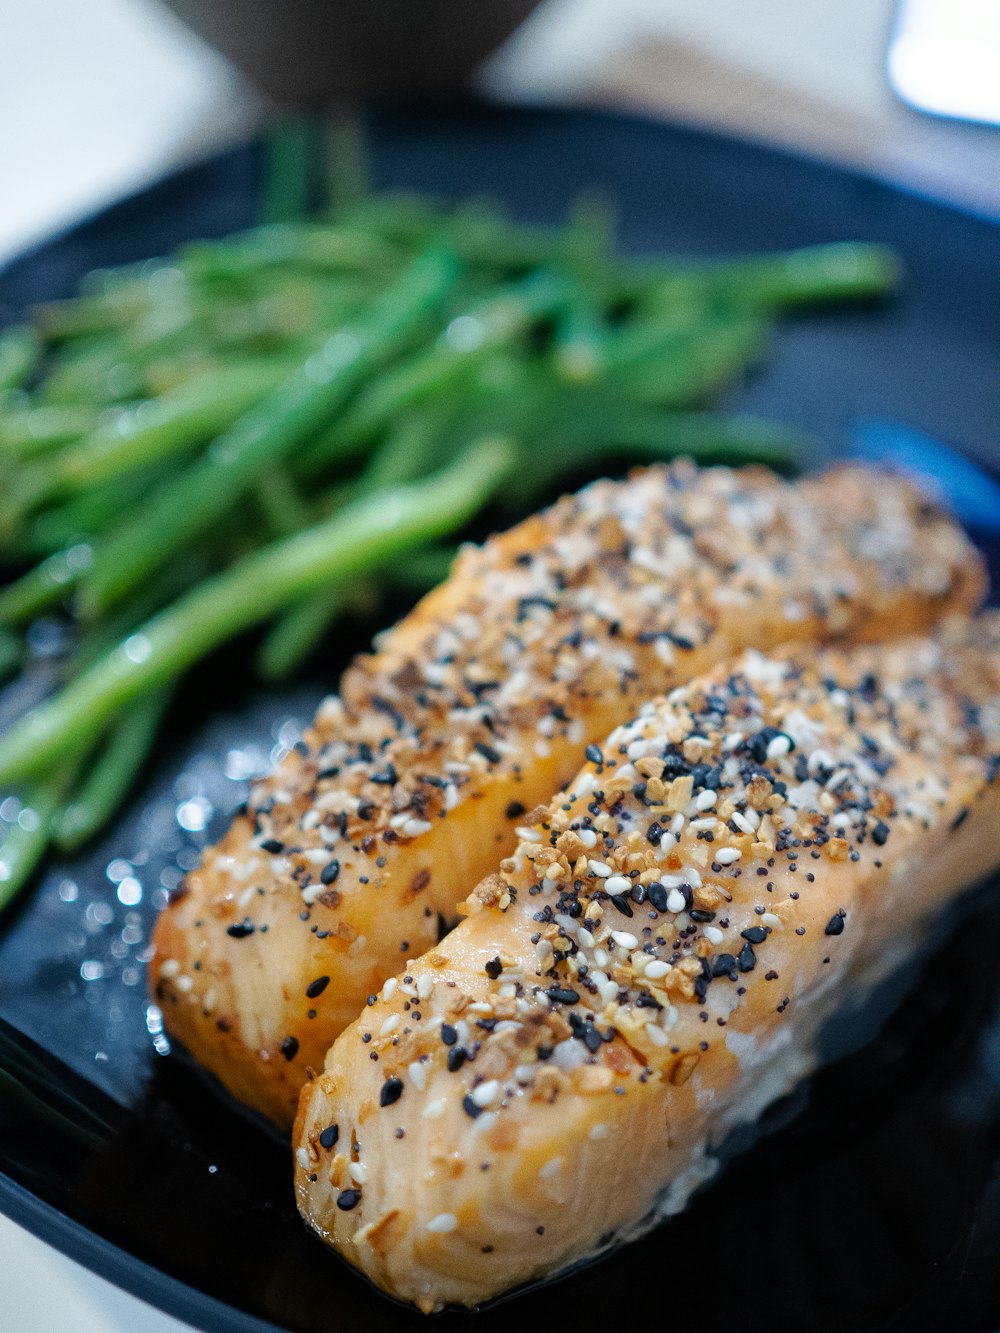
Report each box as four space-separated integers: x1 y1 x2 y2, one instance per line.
295 615 1000 1310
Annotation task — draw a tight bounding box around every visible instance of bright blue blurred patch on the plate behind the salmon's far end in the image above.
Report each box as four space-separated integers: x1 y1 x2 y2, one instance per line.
851 420 1000 537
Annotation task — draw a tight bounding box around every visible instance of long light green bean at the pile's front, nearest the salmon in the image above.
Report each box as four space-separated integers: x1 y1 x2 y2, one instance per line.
0 440 513 784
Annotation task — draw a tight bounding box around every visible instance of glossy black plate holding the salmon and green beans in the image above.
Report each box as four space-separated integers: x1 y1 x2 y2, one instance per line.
0 107 1000 1333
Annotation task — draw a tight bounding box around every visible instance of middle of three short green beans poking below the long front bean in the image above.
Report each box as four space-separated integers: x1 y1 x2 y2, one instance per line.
49 689 171 852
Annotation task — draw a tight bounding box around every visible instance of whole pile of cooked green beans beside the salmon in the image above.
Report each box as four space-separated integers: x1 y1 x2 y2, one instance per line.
0 155 896 906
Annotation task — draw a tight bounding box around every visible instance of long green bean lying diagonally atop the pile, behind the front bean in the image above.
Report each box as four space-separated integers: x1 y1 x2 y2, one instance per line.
80 251 457 617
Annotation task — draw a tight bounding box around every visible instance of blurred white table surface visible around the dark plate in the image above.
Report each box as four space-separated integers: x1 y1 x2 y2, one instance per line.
0 0 1000 1333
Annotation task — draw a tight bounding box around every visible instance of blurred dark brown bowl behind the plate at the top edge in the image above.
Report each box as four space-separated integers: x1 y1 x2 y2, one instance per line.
164 0 539 104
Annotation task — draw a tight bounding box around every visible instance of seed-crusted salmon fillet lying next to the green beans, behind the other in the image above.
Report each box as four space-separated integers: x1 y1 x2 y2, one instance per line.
151 465 983 1125
